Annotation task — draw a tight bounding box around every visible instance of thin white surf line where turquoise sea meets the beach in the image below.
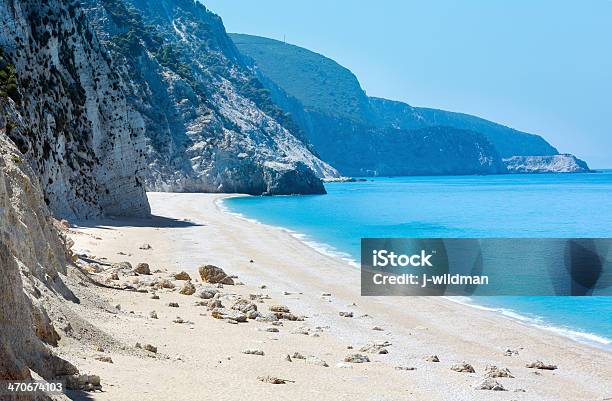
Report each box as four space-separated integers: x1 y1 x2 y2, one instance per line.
215 194 612 353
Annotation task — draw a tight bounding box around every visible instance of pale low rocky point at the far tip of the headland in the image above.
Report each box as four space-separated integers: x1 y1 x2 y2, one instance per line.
504 154 591 174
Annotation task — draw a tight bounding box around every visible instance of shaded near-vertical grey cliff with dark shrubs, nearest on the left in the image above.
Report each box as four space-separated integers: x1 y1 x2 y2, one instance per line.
0 0 149 218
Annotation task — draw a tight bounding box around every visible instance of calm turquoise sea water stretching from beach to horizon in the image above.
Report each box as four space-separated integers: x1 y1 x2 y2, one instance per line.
224 171 612 347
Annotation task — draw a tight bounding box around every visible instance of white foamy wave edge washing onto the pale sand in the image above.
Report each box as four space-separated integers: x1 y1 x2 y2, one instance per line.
215 198 612 348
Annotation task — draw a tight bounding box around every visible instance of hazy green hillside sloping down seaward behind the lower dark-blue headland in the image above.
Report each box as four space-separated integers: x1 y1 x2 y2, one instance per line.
230 34 580 174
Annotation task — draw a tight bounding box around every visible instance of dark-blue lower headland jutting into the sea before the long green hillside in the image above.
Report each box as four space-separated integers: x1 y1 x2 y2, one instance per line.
298 113 505 176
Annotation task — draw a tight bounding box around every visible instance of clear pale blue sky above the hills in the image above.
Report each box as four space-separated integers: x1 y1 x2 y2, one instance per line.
203 0 612 168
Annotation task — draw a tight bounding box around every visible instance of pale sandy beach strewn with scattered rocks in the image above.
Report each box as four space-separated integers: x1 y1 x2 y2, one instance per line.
57 193 612 401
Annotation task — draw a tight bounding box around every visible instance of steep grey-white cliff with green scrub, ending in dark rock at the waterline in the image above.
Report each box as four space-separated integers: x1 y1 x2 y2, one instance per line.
80 0 337 194
